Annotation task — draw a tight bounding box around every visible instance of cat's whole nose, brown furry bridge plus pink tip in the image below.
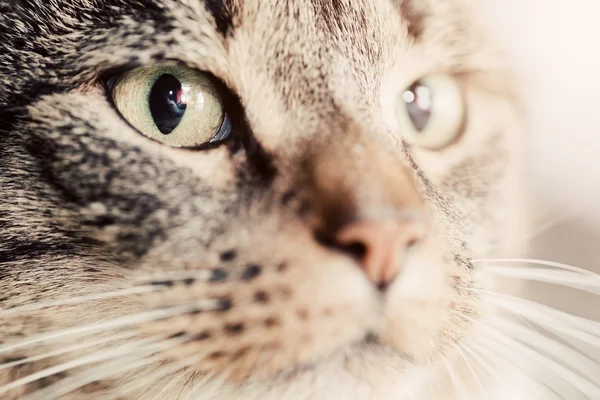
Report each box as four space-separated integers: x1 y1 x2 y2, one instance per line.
294 127 425 291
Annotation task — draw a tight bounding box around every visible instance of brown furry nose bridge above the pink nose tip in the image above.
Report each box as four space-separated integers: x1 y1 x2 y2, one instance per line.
308 133 423 230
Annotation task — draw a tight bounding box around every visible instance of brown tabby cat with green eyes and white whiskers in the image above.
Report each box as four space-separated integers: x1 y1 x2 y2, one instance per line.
0 0 600 400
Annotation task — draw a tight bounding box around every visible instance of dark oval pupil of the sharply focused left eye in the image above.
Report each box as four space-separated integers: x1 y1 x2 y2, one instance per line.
150 74 187 135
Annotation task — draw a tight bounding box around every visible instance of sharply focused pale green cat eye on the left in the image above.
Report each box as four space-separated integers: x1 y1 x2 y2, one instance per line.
109 66 231 148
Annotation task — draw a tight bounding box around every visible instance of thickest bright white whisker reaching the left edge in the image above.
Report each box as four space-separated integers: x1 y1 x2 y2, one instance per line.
0 299 225 354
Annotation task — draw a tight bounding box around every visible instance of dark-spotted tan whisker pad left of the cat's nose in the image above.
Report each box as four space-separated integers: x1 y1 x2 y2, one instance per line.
135 227 381 379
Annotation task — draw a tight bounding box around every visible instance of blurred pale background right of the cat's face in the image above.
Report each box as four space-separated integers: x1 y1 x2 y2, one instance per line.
481 0 600 320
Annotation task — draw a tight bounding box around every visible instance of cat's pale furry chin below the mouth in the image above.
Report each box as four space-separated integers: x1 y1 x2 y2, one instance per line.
154 339 435 400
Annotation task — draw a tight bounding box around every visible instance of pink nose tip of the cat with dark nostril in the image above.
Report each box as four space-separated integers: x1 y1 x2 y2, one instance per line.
335 219 423 291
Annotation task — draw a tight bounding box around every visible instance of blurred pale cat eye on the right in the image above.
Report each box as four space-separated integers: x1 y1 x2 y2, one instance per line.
396 75 466 150
